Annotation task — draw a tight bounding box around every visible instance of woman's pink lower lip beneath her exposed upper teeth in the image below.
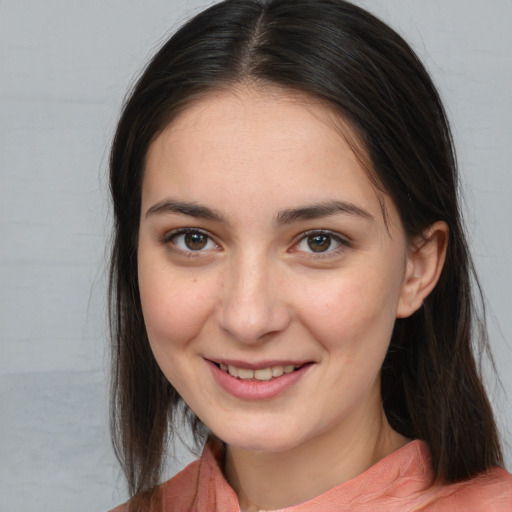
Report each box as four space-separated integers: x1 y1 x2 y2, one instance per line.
207 361 311 400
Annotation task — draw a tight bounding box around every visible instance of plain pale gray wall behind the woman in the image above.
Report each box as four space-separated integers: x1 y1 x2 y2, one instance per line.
0 0 512 512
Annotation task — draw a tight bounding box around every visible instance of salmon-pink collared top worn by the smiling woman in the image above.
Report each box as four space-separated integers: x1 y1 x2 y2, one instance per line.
111 441 512 512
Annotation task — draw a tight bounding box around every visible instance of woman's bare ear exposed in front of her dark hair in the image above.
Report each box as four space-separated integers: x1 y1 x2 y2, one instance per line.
396 221 449 318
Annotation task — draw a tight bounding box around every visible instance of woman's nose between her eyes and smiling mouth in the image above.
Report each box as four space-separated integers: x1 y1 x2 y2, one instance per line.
218 254 290 344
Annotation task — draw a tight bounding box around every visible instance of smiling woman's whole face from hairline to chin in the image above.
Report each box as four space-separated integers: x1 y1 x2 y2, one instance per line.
138 88 414 452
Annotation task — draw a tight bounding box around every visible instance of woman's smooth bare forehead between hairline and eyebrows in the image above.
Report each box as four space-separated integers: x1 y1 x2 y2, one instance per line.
143 87 396 230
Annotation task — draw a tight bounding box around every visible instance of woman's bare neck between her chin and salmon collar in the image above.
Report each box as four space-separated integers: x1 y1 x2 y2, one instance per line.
224 409 408 512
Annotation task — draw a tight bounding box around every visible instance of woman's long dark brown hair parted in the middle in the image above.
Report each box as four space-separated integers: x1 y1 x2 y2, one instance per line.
106 0 502 504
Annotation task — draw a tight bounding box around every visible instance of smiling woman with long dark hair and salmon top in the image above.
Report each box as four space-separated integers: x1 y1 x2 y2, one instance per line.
111 0 512 512
